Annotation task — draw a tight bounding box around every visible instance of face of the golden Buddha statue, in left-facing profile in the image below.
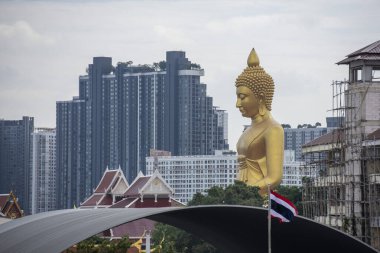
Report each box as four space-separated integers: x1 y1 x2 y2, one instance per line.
236 86 260 118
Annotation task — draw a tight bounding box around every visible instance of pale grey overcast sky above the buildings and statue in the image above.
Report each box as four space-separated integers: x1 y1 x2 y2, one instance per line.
0 0 380 149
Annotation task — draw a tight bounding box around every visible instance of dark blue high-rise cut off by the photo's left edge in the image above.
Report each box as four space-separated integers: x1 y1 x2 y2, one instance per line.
0 117 34 213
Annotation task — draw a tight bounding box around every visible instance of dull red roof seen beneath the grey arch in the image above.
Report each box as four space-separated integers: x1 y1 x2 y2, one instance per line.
112 219 156 238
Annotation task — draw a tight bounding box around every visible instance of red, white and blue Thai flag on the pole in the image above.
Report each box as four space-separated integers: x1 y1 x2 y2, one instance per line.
270 191 298 222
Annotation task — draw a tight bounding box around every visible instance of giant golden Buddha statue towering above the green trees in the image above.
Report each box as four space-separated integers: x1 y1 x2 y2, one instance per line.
235 49 284 195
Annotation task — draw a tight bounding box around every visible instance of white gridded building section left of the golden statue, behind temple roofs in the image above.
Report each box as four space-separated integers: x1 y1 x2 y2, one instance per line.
146 150 237 203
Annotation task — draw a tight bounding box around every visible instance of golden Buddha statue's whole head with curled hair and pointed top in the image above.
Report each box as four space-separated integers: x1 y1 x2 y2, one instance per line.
235 49 274 117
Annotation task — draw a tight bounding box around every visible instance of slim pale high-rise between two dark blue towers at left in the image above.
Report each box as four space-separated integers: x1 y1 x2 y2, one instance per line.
31 128 56 214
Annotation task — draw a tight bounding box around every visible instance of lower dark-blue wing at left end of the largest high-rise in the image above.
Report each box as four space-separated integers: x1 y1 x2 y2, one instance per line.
56 97 86 208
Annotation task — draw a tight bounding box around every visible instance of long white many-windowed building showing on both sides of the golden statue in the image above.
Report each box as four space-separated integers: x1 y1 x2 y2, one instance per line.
146 150 316 203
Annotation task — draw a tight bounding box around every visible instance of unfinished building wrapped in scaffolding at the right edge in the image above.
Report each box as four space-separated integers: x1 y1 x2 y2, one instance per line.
303 41 380 249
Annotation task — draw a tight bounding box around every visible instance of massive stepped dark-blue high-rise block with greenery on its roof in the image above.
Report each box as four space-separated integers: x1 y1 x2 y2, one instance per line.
57 51 228 207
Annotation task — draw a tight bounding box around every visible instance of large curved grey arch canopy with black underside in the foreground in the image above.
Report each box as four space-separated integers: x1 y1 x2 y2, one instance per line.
0 206 377 253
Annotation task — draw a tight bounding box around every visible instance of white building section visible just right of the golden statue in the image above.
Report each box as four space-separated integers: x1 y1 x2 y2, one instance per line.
281 150 317 187
